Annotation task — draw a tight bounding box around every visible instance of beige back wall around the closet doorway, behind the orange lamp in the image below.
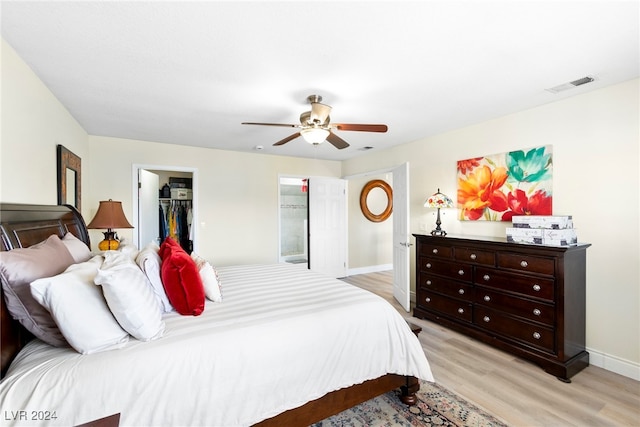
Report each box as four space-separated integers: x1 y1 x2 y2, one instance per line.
86 136 341 266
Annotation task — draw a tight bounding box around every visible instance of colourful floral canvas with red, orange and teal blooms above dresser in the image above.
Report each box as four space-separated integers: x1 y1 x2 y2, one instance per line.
457 145 553 221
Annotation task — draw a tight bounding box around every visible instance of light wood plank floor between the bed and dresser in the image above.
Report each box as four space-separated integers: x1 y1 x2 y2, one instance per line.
343 271 640 427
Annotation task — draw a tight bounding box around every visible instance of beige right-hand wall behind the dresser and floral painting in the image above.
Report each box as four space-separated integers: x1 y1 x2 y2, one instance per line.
343 79 640 379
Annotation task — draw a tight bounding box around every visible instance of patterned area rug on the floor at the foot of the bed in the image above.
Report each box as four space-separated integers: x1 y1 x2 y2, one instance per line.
313 381 506 427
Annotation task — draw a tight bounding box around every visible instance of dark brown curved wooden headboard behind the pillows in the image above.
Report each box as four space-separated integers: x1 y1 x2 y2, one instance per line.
0 203 91 377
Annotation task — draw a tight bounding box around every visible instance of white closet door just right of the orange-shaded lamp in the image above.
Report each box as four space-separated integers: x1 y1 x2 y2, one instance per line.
138 169 160 249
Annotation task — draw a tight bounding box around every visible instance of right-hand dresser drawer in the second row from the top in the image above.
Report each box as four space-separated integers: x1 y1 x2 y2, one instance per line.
474 267 555 301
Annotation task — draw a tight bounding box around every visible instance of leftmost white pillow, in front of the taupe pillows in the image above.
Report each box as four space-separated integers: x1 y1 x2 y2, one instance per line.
31 255 129 354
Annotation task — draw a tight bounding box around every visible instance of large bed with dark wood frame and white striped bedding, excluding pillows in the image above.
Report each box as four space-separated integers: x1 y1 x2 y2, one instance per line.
0 204 433 426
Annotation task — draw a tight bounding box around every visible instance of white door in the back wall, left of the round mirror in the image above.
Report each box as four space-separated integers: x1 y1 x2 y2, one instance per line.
309 178 347 278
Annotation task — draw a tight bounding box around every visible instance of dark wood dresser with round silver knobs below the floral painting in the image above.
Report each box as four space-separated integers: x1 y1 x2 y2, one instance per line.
414 234 590 382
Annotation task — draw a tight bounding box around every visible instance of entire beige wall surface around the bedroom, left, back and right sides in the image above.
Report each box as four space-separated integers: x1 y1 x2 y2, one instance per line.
0 34 640 379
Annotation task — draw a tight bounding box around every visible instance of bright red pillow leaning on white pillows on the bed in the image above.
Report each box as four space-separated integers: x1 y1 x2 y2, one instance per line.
158 237 205 316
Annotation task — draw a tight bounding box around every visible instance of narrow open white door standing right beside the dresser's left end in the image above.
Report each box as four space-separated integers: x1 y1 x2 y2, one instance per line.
393 163 411 311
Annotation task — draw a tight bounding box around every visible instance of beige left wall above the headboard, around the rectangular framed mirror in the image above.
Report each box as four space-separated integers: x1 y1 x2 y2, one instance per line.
0 39 89 210
